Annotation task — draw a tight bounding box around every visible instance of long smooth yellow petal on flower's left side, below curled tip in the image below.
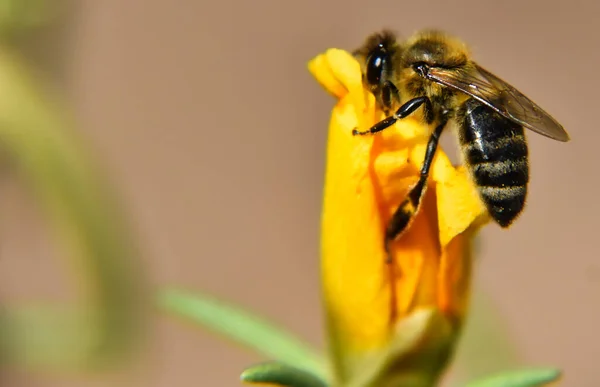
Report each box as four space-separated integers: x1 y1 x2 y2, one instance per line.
322 92 391 354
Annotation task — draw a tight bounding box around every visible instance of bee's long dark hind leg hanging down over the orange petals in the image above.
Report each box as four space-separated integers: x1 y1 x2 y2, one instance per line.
384 121 446 263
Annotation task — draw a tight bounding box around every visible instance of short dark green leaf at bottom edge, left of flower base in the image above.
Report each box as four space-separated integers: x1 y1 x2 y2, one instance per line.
240 362 327 387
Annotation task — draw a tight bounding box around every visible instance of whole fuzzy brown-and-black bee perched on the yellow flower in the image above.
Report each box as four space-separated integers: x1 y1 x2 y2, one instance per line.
353 30 569 261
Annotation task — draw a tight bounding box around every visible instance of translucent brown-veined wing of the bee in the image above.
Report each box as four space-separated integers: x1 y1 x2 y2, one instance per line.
427 64 569 141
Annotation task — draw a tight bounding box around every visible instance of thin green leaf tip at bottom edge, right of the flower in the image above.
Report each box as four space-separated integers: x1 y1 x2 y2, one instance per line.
467 368 561 387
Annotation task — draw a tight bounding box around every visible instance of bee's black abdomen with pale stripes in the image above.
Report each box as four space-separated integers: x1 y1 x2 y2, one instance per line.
459 99 529 227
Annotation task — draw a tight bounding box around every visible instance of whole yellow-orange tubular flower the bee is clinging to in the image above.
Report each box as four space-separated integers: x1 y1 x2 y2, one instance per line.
309 49 488 387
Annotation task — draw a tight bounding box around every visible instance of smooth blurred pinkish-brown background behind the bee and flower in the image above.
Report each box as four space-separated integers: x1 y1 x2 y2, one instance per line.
0 0 600 387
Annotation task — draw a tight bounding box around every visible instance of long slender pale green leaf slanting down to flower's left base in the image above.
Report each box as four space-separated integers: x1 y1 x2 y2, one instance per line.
158 289 325 378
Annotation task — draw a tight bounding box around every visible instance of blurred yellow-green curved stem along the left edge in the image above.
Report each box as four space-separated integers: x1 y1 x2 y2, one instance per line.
0 0 148 370
